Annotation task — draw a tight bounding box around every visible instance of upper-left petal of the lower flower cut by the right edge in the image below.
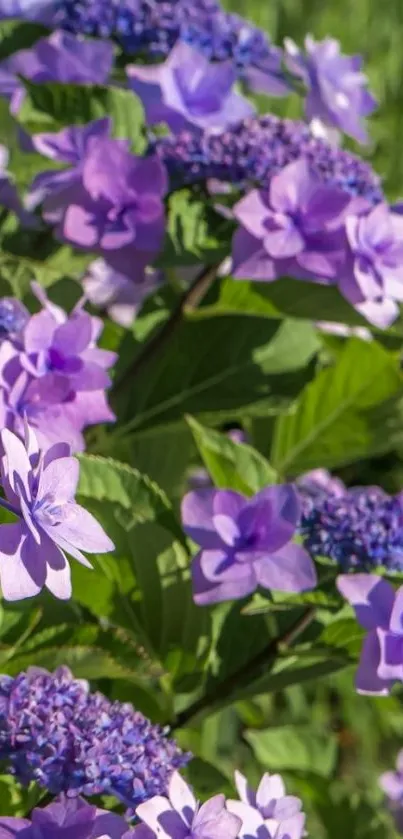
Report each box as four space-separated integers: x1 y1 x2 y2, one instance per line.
336 574 395 629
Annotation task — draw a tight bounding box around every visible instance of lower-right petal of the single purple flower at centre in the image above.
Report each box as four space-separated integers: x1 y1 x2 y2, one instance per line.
254 542 317 593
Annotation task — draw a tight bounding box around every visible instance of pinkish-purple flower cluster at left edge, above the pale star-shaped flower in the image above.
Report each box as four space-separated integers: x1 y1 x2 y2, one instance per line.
0 284 116 451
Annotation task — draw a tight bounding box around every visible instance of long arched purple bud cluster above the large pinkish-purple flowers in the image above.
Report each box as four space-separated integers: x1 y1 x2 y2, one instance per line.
153 115 383 204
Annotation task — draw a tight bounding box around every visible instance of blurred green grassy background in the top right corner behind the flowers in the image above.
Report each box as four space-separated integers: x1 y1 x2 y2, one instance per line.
224 0 403 199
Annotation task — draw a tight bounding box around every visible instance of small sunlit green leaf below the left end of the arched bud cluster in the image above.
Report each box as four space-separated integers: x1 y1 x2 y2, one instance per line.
159 189 233 269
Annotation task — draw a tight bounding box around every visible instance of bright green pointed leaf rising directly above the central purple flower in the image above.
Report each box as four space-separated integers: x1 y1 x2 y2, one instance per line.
186 417 276 495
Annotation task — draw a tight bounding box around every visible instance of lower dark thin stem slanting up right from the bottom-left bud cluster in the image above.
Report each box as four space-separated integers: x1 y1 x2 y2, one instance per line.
171 606 316 730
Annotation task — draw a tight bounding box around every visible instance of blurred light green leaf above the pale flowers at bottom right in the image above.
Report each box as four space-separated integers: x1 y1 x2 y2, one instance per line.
244 725 337 777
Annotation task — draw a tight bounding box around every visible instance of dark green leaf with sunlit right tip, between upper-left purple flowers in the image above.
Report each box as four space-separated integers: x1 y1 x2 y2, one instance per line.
18 80 147 154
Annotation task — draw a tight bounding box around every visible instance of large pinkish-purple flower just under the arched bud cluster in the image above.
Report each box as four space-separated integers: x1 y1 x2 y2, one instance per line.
233 159 351 280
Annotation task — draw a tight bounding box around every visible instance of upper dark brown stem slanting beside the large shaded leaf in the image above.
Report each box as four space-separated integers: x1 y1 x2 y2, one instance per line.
113 263 221 394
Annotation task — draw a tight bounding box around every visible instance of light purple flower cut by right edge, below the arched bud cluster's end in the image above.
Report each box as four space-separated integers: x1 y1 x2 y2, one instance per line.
339 204 403 328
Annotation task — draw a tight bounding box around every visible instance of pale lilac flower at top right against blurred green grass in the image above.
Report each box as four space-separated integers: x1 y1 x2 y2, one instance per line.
286 35 377 143
